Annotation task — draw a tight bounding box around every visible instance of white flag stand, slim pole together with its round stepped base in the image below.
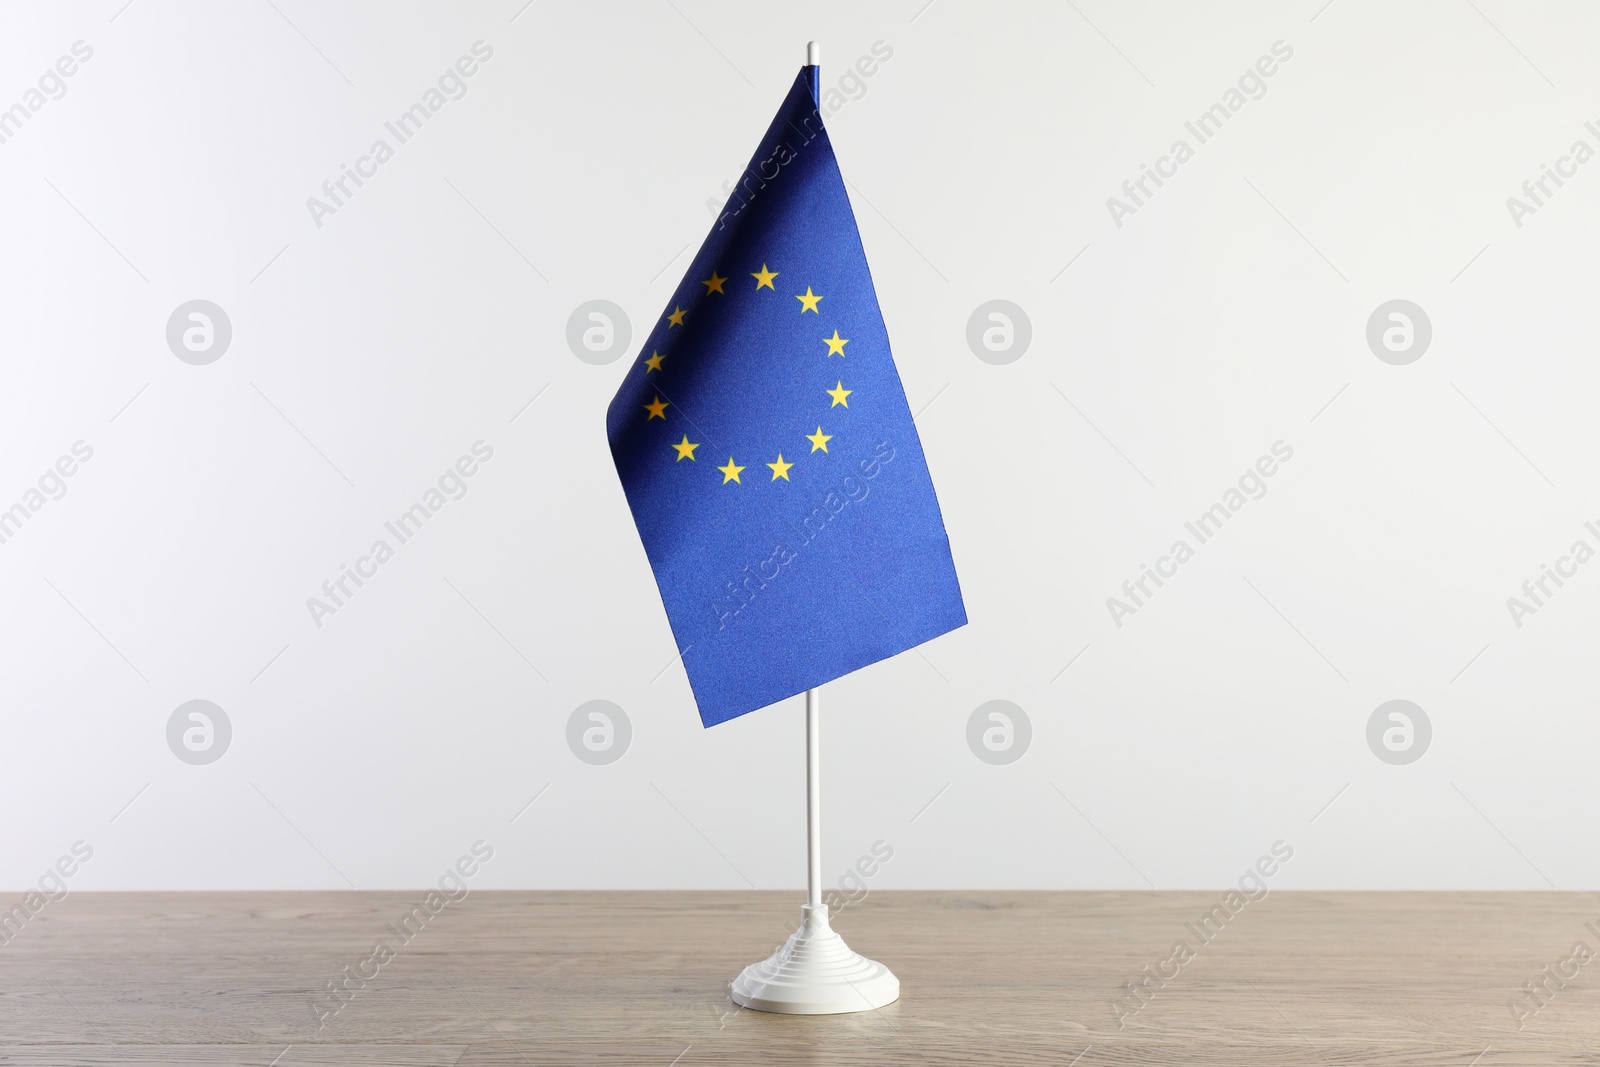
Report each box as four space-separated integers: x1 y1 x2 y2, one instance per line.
733 681 899 1016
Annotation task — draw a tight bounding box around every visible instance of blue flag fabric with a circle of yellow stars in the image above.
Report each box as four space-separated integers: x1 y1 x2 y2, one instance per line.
606 58 966 726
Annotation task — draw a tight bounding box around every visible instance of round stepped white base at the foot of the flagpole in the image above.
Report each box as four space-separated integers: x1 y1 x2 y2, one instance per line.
733 904 899 1016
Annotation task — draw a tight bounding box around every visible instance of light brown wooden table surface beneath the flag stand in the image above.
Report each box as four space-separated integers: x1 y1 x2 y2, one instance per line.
0 891 1600 1067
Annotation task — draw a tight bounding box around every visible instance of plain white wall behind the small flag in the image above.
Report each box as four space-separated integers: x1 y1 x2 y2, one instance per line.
0 0 1600 891
